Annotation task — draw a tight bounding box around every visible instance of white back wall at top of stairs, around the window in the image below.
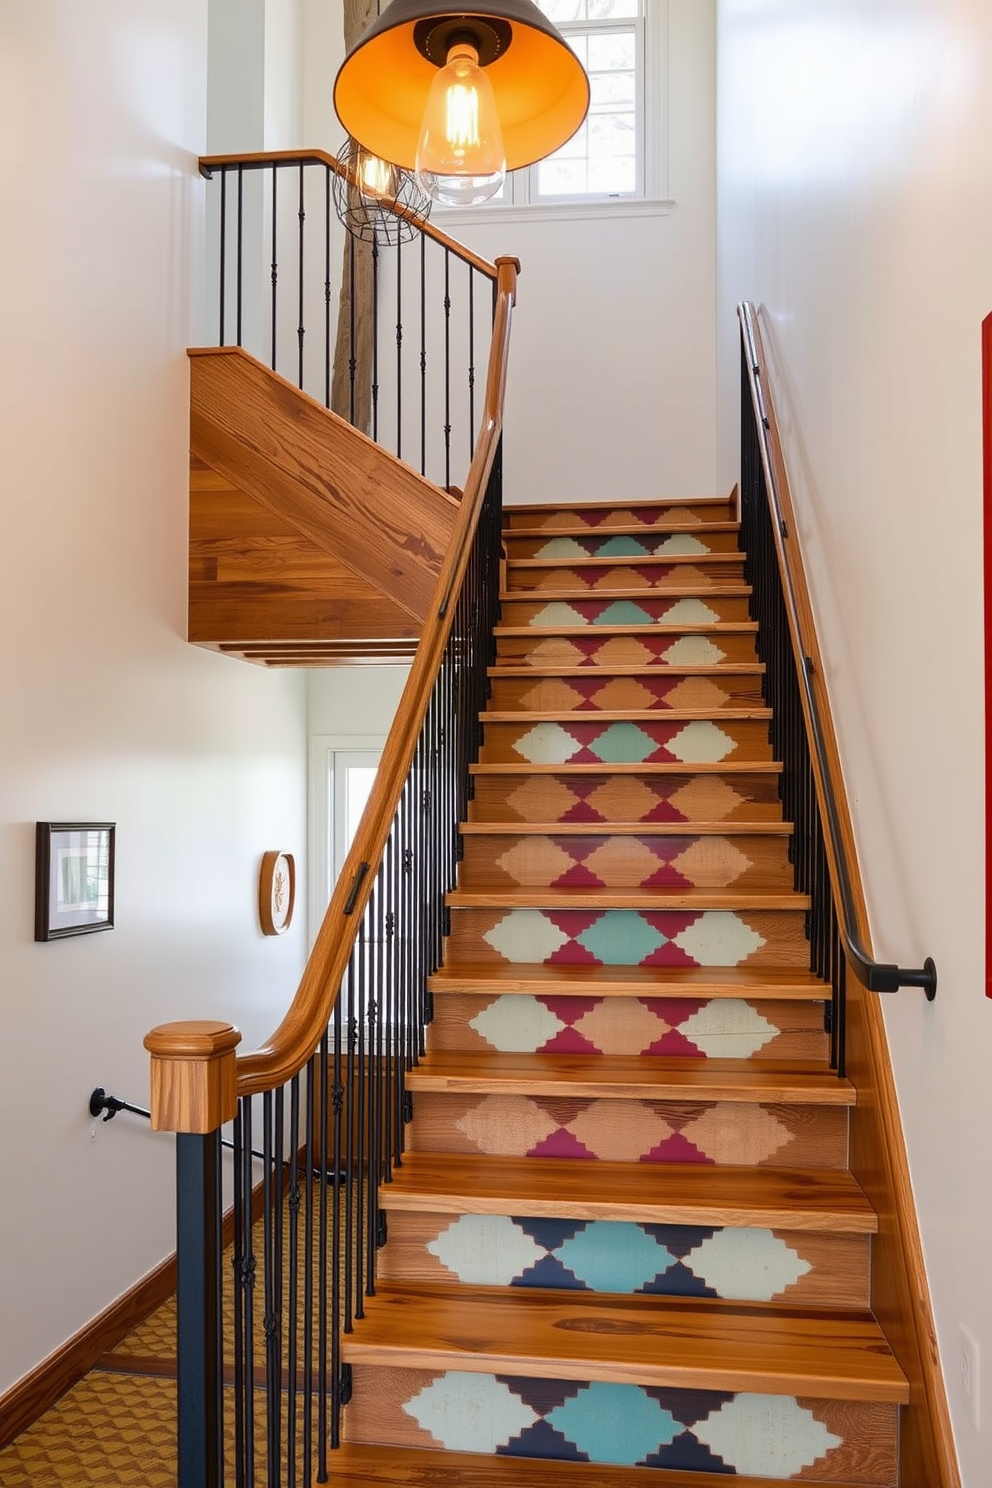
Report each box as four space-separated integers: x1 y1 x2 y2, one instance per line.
303 0 715 501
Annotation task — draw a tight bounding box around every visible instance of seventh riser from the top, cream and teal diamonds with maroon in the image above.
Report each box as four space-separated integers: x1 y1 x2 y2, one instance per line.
479 719 772 765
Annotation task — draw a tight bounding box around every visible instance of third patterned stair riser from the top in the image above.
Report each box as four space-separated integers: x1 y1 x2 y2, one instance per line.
507 554 744 595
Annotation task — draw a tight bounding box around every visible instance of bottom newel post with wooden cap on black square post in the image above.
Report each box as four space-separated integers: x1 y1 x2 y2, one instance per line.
144 1021 241 1488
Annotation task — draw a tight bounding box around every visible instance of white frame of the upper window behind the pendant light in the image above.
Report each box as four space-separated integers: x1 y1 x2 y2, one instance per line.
433 0 675 225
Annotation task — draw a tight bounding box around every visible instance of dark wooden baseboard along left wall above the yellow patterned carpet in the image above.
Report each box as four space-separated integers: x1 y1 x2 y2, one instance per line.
0 1183 262 1451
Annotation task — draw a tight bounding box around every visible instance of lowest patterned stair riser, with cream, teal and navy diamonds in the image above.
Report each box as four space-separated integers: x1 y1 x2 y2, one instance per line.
345 1364 897 1485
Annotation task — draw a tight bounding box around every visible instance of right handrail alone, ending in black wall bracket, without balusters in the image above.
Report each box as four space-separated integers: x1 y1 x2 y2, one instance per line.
738 302 937 1001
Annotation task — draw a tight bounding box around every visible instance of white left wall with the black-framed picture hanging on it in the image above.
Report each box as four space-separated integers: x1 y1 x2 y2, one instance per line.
0 0 305 1391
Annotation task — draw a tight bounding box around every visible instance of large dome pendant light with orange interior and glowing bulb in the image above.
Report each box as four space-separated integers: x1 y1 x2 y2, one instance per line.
335 0 589 205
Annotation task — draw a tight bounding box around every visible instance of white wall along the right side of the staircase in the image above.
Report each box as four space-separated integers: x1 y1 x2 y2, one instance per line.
718 0 992 1488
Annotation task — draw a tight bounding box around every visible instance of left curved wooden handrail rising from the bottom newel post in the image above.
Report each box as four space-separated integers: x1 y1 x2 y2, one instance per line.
236 257 519 1095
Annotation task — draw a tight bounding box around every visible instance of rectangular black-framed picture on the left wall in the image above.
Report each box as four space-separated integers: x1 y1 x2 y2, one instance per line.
34 821 116 940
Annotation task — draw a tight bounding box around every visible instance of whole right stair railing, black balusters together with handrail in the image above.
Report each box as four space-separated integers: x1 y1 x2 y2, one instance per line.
738 304 937 1070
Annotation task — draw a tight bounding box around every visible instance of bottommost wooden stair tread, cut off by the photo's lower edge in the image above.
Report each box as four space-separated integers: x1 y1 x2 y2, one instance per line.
330 1442 858 1488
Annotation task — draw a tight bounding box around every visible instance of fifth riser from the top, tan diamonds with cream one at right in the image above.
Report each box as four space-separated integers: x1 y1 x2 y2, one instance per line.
497 626 759 670
